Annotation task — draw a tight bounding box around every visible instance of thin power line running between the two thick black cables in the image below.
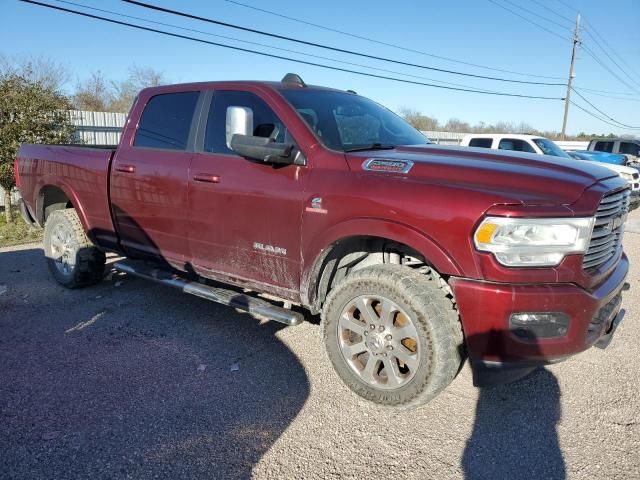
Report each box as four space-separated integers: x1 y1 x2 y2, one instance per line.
54 0 500 92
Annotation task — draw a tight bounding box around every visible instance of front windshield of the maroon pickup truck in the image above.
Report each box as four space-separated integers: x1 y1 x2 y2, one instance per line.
281 89 431 152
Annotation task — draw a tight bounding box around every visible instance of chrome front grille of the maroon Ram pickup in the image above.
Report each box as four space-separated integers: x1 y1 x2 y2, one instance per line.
582 189 631 269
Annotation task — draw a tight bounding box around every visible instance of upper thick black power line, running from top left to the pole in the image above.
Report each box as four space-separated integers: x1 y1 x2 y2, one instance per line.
121 0 564 86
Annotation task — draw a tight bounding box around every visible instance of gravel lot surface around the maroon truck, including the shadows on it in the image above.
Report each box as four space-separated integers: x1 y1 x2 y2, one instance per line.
0 212 640 479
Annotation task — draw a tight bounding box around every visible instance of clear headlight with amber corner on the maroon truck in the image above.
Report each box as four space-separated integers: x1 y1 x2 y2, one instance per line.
473 217 594 267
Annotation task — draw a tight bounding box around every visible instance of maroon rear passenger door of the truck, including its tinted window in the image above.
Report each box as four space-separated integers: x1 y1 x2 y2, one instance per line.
111 91 200 262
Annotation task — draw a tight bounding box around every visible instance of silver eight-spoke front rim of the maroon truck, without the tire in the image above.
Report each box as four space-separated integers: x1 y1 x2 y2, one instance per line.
338 295 420 390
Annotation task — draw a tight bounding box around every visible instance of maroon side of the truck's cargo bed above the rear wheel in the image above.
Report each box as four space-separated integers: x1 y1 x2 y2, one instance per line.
16 144 117 248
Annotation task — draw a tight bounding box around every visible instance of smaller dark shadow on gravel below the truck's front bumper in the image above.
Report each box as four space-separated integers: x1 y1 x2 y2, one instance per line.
462 332 566 480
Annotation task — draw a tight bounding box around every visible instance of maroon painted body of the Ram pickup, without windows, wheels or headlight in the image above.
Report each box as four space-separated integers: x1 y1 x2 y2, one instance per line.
17 78 628 386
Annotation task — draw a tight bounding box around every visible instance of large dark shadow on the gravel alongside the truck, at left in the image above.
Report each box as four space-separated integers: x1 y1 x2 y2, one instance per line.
0 248 309 479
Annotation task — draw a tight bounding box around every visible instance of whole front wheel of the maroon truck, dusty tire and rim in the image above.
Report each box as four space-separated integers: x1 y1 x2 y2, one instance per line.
323 265 463 407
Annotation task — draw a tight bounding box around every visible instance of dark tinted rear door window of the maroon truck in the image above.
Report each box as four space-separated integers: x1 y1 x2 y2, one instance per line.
133 92 200 150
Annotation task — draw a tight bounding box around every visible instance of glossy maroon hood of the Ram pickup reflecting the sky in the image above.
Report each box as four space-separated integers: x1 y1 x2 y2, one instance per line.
346 144 617 205
